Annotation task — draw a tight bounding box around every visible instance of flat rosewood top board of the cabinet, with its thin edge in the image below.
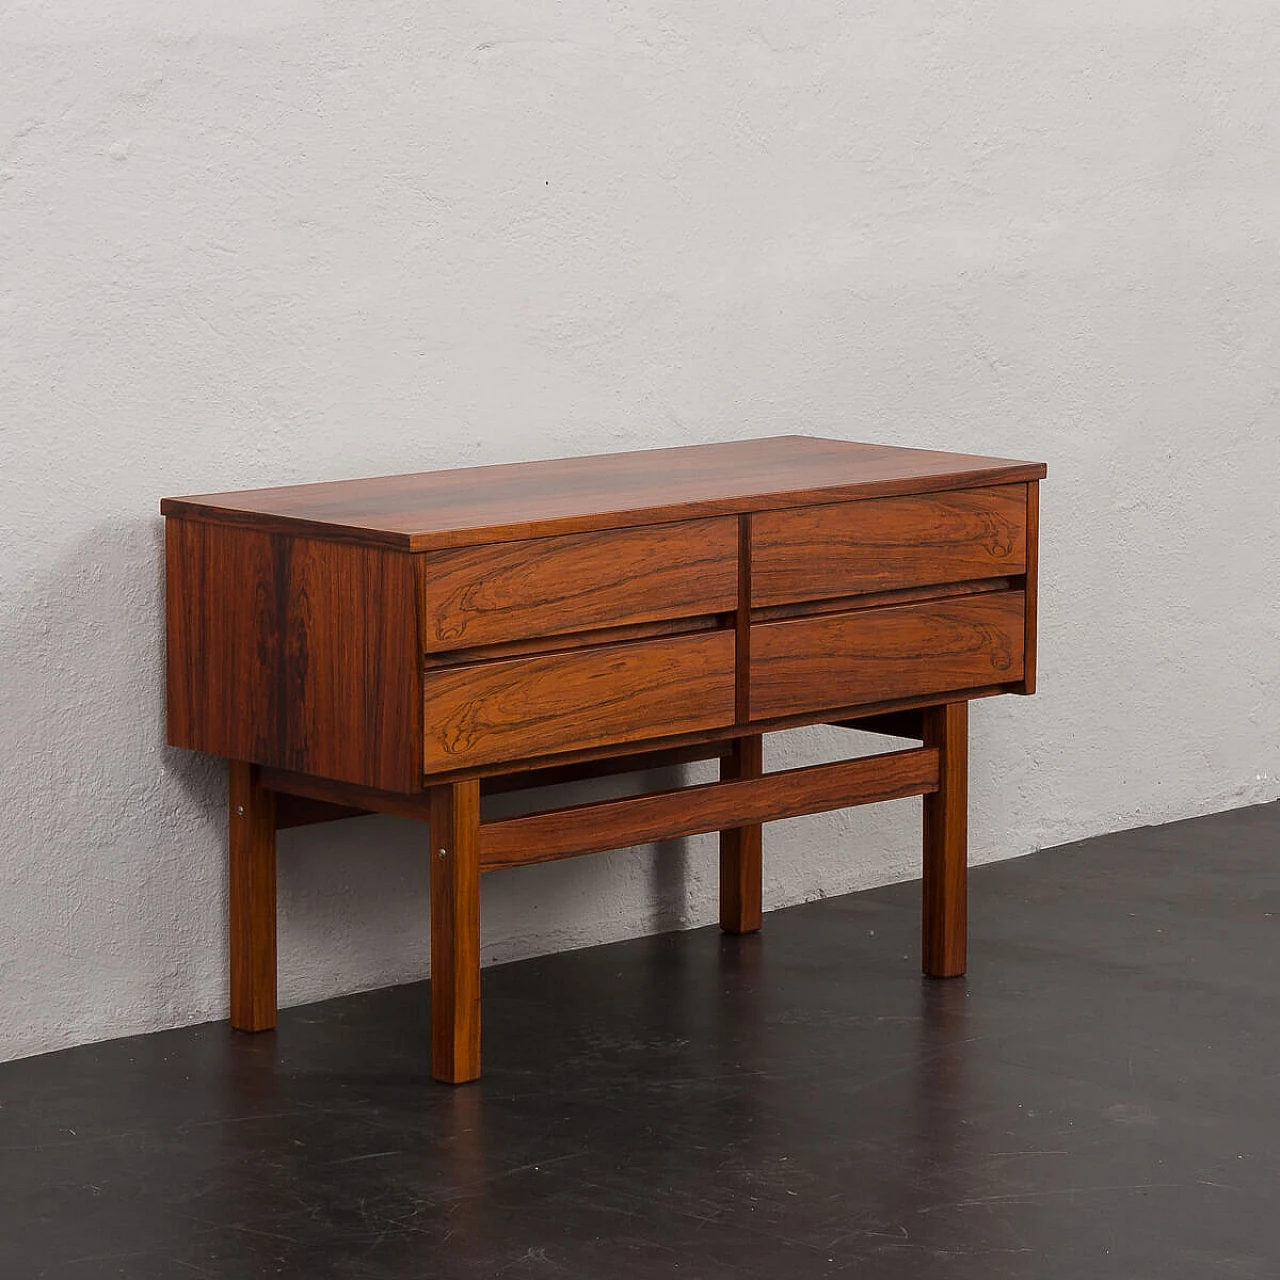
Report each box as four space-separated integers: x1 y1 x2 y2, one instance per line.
160 435 1046 552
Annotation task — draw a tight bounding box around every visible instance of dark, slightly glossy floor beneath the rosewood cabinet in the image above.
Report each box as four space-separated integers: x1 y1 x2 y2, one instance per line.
0 805 1280 1280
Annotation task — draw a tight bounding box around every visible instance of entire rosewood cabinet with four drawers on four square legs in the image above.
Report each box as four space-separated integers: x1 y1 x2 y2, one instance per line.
161 436 1044 1083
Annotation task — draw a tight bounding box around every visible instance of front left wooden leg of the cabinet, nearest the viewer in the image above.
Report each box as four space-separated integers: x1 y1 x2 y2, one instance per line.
431 780 480 1084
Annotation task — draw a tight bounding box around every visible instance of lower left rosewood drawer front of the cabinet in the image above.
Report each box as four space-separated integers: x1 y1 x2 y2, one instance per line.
422 631 735 773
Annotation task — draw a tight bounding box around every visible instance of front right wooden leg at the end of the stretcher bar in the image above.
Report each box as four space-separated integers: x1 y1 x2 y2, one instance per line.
922 703 969 978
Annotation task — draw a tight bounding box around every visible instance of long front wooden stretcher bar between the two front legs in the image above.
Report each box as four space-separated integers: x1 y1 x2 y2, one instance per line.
480 748 938 870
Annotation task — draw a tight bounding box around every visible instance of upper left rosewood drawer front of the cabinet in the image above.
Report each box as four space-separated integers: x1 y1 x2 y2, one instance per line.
419 516 737 653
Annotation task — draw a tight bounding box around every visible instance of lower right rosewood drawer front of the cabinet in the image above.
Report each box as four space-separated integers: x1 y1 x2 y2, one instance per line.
750 591 1027 719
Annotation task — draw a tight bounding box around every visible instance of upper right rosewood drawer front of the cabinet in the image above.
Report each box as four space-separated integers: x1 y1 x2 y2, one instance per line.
751 484 1027 607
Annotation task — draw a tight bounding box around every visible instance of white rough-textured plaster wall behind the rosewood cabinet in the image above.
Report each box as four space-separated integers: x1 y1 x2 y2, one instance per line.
0 0 1280 1056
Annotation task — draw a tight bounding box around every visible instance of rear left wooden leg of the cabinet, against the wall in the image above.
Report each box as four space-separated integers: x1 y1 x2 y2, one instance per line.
227 760 275 1032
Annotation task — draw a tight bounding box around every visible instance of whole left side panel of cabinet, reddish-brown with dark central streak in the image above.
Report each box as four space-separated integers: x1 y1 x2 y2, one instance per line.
165 518 421 791
